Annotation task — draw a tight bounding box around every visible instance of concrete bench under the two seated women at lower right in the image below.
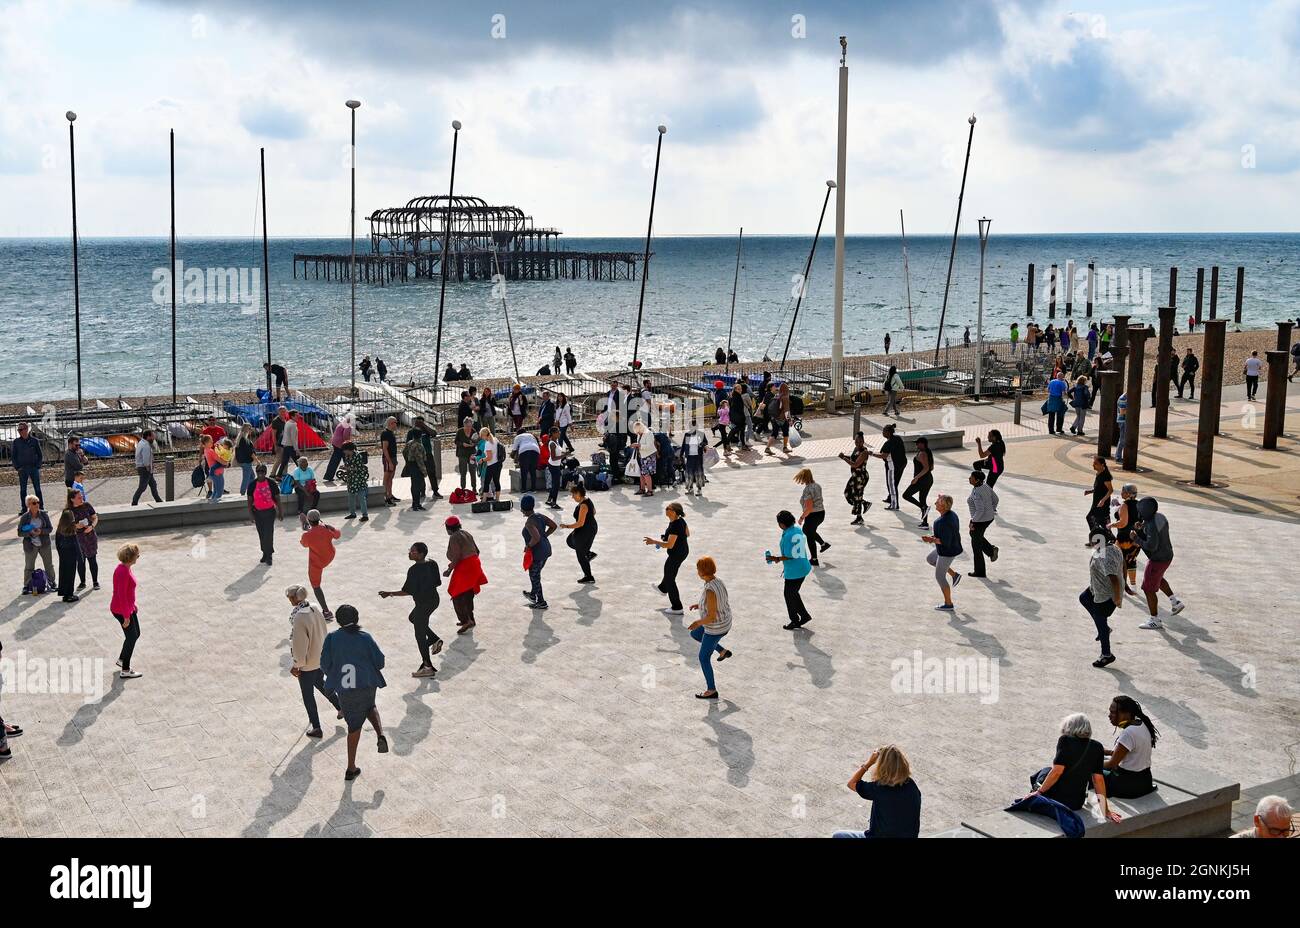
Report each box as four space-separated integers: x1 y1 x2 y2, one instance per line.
945 767 1242 838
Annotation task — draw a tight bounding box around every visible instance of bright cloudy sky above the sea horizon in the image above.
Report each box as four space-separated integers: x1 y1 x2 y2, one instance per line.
0 0 1300 237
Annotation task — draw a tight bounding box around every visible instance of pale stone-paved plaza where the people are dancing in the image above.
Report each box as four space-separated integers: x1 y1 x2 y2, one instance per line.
0 428 1300 837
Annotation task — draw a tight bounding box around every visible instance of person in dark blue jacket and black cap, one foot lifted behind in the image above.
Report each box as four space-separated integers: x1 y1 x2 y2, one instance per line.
321 604 389 780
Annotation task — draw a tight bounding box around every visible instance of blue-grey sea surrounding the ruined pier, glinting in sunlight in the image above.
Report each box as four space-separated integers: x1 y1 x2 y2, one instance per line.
0 234 1300 407
